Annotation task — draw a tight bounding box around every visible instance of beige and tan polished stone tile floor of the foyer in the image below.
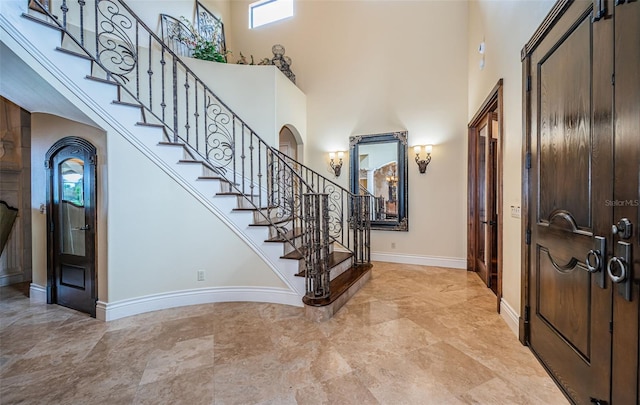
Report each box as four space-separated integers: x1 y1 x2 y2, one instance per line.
0 263 567 405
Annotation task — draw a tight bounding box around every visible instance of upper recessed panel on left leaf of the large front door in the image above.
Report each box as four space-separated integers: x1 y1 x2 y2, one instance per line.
537 19 591 228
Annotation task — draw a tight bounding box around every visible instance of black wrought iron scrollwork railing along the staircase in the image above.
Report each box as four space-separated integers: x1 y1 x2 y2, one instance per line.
30 0 369 296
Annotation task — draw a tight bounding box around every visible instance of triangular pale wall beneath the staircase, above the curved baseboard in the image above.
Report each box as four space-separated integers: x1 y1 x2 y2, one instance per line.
108 129 286 302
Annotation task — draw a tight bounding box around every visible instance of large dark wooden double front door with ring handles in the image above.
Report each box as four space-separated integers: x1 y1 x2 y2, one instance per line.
525 0 640 405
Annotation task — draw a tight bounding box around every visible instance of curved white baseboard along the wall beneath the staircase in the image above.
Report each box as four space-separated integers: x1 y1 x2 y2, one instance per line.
96 287 302 321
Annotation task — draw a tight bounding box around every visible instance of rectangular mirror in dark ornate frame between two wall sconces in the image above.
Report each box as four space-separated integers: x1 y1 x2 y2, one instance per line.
350 132 408 231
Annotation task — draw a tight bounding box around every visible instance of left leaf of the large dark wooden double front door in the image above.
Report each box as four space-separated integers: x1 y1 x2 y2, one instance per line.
528 0 616 404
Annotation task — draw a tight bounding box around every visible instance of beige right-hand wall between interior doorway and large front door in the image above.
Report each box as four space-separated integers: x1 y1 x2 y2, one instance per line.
468 0 554 312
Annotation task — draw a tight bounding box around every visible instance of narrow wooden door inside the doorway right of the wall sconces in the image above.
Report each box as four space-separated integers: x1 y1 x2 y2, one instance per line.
475 112 498 291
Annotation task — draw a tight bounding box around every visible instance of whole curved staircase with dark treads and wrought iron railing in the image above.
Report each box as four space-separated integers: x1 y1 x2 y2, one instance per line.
5 0 371 320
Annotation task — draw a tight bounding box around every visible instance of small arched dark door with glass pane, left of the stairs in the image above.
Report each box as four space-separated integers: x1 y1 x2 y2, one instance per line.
47 138 96 316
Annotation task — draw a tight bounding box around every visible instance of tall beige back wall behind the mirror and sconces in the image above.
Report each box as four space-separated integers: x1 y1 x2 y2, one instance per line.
227 0 468 259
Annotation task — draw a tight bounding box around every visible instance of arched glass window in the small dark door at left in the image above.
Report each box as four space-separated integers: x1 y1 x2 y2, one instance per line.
59 158 86 256
